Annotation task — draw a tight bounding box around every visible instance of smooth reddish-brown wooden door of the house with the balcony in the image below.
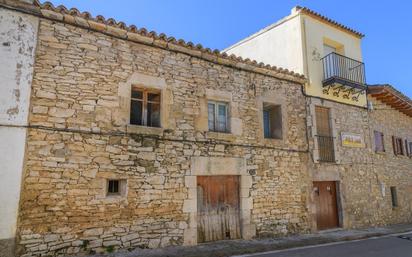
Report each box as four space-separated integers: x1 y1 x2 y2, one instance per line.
313 181 339 230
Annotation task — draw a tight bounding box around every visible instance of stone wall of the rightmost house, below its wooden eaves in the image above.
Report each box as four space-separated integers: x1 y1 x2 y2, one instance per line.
369 97 412 224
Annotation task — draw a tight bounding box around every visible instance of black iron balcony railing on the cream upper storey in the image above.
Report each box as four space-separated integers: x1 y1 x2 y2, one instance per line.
322 53 366 90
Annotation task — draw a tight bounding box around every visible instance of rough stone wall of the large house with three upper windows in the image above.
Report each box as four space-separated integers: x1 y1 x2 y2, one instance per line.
19 19 309 256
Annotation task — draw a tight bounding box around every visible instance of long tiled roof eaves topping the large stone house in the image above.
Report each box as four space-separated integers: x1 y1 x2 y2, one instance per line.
21 0 306 84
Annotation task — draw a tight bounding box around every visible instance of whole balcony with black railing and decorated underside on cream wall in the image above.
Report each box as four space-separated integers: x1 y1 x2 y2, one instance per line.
321 53 367 101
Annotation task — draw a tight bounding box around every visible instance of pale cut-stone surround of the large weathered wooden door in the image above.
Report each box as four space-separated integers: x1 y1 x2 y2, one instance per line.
183 157 256 245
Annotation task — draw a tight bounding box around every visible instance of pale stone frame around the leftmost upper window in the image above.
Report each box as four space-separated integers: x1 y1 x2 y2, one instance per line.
118 72 174 135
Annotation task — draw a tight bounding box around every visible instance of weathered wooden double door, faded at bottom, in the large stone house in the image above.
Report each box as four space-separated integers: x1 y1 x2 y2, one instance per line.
197 176 240 243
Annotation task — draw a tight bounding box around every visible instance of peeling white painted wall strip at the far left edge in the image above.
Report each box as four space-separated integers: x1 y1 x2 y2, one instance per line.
0 9 39 240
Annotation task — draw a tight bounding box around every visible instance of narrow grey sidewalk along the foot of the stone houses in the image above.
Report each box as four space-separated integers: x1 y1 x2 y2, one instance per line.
91 224 412 257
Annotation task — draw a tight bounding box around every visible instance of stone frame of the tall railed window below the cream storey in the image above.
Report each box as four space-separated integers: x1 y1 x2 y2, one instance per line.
308 98 341 164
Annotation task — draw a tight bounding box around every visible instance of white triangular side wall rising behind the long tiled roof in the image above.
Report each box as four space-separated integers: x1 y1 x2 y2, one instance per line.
223 15 304 74
